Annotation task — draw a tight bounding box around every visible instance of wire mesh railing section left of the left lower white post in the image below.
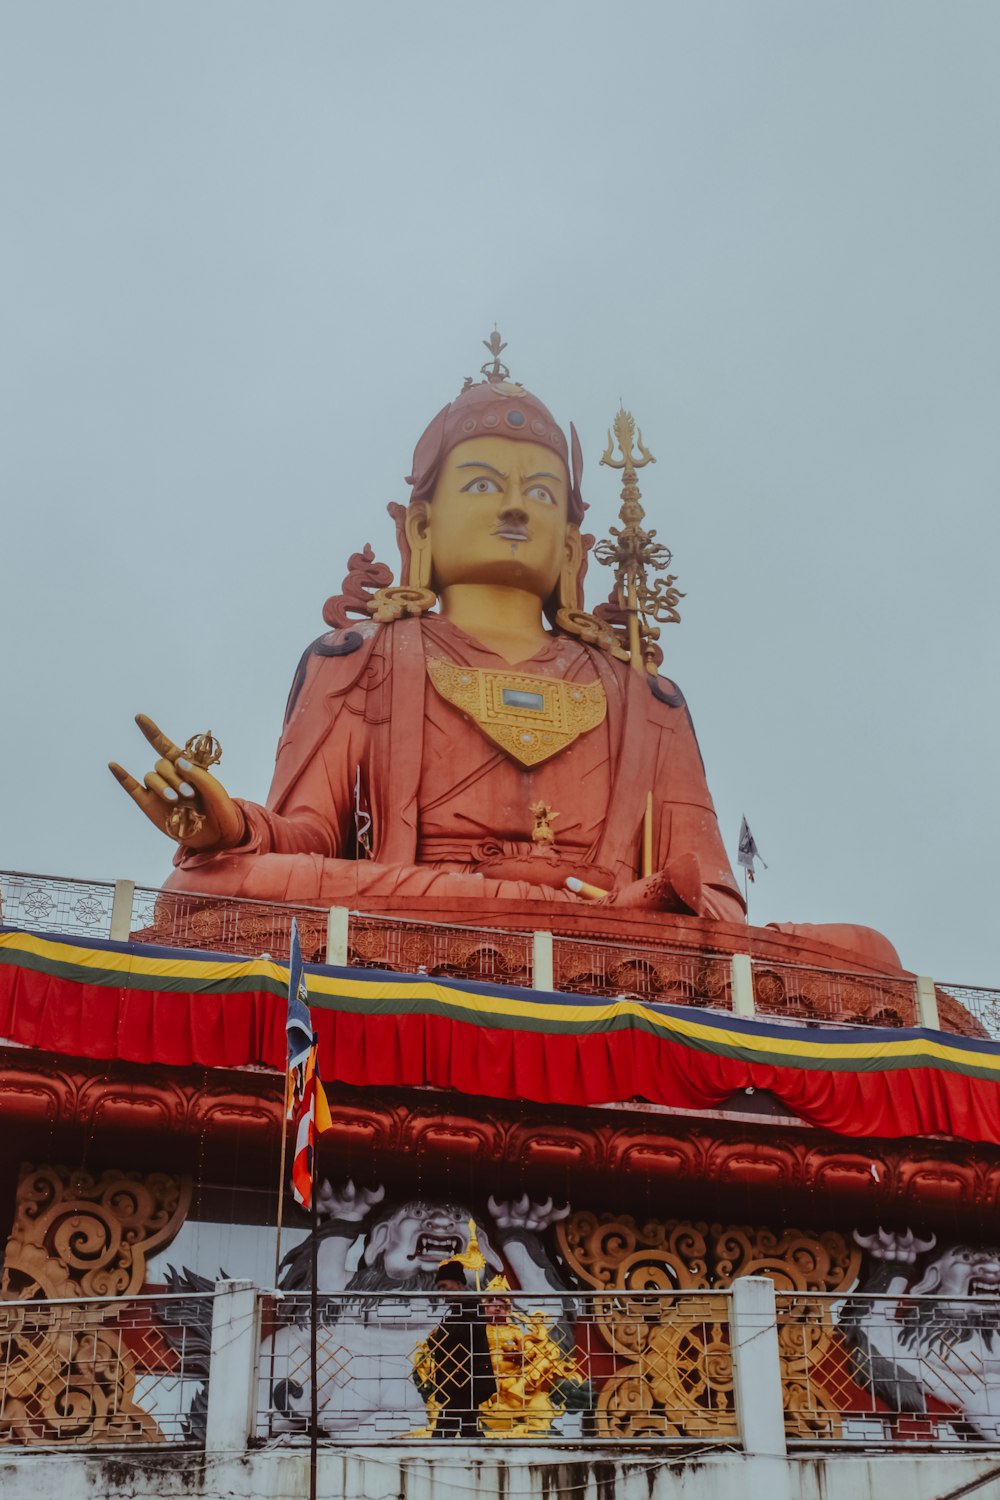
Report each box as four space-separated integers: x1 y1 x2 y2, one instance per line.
0 1295 211 1448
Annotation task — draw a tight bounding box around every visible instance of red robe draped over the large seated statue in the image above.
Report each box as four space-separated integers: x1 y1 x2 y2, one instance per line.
169 617 744 921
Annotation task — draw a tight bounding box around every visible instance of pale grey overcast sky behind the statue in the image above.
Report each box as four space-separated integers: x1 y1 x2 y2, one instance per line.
0 0 1000 986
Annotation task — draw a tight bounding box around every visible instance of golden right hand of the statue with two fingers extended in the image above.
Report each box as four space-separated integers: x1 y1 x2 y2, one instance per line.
108 714 244 849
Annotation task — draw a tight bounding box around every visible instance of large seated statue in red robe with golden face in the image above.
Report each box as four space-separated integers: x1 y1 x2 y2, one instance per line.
111 340 895 962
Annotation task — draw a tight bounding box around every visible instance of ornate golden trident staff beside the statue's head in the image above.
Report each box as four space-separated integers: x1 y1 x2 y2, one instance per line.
594 407 684 675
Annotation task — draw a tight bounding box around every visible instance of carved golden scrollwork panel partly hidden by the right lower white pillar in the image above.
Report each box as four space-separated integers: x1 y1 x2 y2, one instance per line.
556 1212 861 1439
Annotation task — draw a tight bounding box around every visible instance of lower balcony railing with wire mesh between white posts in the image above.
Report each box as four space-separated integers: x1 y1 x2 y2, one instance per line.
0 1275 1000 1455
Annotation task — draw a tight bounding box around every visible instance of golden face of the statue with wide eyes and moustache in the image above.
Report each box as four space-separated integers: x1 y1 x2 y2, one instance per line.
424 437 570 599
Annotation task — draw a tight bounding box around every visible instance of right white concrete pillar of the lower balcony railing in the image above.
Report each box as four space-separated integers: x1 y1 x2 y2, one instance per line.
729 1277 786 1455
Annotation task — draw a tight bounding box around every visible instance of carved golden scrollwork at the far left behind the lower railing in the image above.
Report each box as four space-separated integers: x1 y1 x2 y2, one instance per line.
0 1166 192 1443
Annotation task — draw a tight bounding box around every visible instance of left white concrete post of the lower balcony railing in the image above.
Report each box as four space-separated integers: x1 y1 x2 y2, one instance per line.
205 1281 258 1454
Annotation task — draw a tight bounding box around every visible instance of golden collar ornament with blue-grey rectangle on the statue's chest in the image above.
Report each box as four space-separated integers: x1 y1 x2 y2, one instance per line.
427 657 607 767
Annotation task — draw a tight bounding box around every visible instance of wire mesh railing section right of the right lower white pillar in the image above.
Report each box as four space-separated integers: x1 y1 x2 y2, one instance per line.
777 1293 1000 1449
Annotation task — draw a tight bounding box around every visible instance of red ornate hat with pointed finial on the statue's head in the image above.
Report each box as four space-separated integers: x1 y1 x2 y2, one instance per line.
406 332 586 525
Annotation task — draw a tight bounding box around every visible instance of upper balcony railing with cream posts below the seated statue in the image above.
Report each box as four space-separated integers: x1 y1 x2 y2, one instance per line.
0 870 1000 1040
